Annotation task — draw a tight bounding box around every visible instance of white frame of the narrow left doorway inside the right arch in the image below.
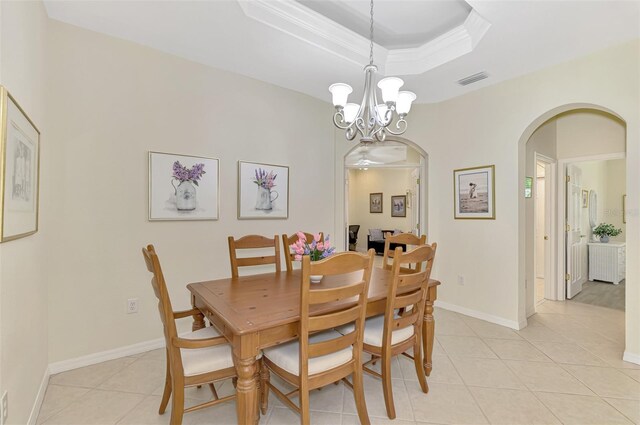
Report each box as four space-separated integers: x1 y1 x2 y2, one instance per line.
533 152 562 304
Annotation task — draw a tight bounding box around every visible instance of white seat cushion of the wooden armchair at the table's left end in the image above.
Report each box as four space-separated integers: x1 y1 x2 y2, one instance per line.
180 326 233 376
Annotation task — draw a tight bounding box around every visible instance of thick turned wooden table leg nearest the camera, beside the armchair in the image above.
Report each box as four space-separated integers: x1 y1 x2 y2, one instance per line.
233 354 259 425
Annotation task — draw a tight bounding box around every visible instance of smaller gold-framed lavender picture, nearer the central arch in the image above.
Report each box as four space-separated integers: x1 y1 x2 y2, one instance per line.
238 161 289 220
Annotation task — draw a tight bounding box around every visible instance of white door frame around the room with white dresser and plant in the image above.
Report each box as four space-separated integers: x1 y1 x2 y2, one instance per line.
556 152 627 301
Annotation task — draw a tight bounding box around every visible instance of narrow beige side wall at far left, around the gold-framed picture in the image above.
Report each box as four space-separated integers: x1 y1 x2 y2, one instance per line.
0 1 49 424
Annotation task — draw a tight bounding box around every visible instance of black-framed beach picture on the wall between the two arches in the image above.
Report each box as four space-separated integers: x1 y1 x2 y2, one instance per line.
453 165 496 220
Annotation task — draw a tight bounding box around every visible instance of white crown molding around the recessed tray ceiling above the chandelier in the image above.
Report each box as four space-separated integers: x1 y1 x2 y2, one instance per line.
238 0 491 75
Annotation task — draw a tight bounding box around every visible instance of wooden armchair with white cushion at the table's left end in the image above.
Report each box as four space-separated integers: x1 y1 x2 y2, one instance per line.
142 245 236 424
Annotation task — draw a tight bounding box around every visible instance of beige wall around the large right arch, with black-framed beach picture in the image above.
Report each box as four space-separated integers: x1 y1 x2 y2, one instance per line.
335 41 640 355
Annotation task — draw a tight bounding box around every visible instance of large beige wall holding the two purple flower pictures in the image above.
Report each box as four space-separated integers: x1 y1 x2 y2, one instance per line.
48 21 334 362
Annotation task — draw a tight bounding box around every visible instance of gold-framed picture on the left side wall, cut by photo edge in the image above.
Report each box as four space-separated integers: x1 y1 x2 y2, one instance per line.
0 86 40 242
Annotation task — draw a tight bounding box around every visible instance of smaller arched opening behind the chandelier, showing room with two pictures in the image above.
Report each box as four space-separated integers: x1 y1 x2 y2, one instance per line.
343 137 428 251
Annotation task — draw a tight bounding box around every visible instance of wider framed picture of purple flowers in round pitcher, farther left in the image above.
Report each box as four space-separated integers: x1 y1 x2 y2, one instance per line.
149 152 220 221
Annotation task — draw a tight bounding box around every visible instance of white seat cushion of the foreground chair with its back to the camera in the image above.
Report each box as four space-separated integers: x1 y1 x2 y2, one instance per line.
263 330 353 376
